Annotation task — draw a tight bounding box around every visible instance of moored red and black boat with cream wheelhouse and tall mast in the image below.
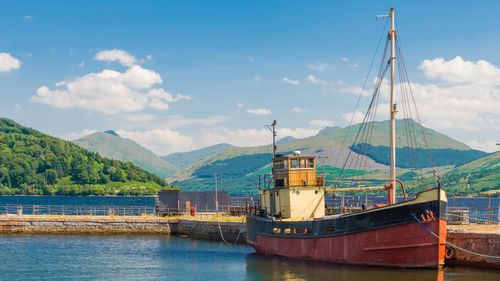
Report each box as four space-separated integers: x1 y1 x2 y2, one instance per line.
246 9 447 268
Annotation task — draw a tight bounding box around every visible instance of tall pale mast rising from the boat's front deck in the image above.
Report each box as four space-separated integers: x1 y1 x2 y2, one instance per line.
388 8 397 204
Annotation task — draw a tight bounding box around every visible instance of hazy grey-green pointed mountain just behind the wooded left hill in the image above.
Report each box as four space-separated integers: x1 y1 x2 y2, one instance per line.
73 130 177 178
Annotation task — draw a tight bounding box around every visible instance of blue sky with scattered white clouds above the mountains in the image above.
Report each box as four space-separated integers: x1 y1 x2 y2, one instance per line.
0 0 500 155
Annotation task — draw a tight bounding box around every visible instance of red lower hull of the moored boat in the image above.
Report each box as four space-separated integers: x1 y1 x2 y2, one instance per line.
249 220 446 267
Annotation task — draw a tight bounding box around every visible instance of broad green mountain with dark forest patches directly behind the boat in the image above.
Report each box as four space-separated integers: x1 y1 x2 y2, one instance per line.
172 120 486 194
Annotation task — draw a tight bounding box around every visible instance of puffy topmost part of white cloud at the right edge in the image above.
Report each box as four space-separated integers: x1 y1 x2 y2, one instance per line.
418 56 500 86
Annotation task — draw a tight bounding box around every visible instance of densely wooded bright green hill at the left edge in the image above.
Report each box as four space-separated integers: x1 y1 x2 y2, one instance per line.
0 118 176 195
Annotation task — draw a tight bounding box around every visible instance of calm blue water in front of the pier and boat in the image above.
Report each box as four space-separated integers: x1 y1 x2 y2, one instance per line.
0 235 500 281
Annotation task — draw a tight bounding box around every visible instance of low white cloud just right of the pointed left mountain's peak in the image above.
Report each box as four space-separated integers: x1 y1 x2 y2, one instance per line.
117 128 195 155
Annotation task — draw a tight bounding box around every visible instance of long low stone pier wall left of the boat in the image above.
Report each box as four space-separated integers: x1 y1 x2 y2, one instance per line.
0 215 245 243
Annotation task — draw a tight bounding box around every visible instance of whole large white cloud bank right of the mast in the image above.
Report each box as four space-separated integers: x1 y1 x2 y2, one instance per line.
412 56 500 133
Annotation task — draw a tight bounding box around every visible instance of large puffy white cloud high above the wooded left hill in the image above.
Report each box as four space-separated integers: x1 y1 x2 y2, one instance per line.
32 51 191 114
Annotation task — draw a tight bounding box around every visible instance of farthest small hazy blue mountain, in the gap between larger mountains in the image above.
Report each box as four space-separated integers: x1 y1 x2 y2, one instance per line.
161 143 234 169
